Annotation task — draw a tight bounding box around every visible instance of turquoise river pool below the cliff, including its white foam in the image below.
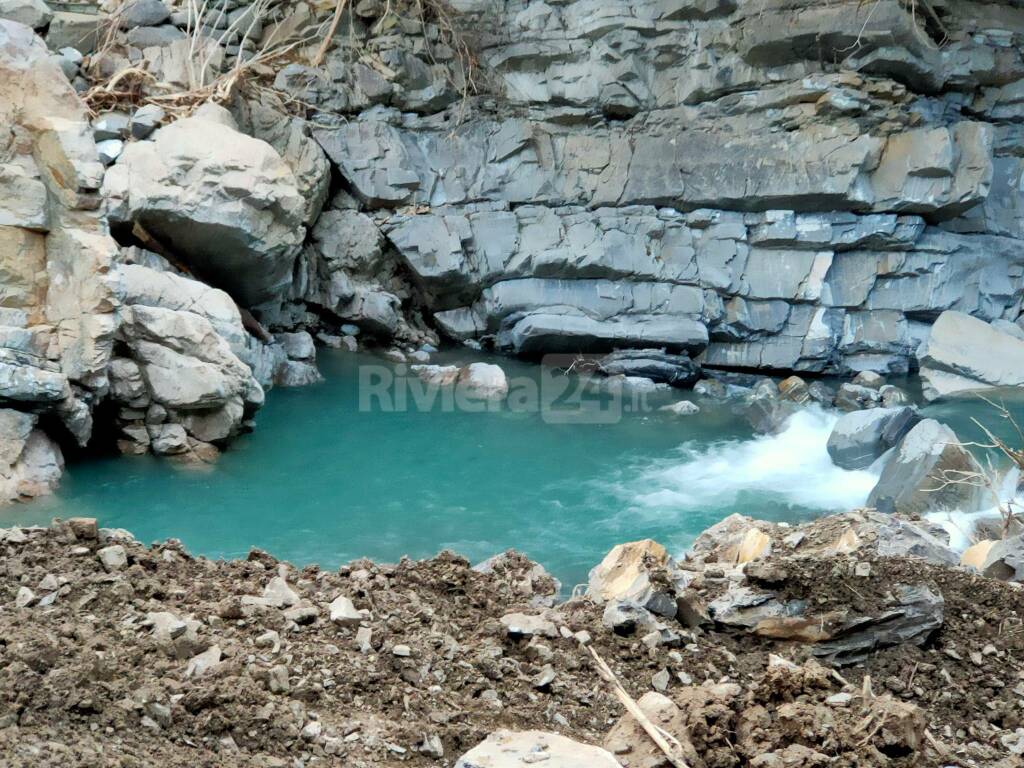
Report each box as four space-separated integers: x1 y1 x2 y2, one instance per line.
0 350 1019 588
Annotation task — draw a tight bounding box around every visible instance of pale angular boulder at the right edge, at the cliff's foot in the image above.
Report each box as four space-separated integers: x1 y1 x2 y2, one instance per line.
918 310 1024 400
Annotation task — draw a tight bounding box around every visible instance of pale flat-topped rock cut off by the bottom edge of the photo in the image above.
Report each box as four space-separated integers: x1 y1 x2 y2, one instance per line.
455 730 621 768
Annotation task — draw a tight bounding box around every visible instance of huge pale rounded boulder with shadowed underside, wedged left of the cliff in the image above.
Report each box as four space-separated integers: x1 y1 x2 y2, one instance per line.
103 105 306 306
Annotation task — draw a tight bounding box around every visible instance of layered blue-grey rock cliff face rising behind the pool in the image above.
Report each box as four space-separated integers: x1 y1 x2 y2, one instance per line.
306 0 1024 373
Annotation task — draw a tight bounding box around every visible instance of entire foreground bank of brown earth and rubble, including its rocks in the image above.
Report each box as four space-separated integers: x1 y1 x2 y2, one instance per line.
0 518 1024 768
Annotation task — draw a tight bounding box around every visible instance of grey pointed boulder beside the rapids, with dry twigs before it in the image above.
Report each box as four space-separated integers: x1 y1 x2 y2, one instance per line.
867 419 986 515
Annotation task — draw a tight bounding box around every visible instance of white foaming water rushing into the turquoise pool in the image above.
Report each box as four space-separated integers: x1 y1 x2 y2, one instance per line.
617 409 879 514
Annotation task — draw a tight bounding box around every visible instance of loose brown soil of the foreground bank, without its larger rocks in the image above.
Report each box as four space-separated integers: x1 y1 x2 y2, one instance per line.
0 524 1024 768
